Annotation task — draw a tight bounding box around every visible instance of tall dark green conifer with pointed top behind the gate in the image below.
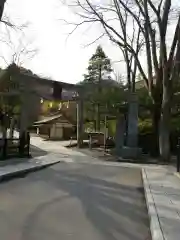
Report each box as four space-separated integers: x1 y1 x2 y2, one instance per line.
81 46 125 130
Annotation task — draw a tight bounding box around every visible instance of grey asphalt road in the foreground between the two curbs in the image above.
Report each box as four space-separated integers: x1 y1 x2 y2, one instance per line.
0 163 150 240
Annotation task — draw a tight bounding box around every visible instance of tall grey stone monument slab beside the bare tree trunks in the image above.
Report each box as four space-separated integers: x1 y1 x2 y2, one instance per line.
127 93 138 148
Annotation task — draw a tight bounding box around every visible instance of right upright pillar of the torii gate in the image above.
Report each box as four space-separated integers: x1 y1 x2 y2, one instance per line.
77 92 84 148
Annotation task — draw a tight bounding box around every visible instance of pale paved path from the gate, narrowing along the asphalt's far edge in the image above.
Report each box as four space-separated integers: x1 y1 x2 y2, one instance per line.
31 136 174 170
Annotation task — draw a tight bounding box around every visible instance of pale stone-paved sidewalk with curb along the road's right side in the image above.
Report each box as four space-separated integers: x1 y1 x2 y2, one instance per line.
142 167 180 240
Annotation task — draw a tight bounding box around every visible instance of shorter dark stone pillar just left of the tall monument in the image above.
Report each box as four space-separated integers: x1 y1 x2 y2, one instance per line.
115 116 125 155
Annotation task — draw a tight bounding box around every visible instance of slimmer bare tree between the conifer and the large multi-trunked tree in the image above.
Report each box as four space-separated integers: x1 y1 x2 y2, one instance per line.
61 0 143 91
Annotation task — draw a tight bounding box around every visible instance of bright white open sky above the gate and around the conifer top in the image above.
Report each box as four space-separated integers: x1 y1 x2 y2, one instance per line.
0 0 122 83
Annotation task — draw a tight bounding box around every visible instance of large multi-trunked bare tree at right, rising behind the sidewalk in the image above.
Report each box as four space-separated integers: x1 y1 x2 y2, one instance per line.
62 0 180 160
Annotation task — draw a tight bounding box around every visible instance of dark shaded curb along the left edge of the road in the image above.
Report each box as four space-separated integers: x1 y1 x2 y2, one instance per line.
0 161 61 183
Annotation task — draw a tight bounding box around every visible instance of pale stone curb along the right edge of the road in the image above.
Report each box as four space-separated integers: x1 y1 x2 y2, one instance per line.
142 168 165 240
